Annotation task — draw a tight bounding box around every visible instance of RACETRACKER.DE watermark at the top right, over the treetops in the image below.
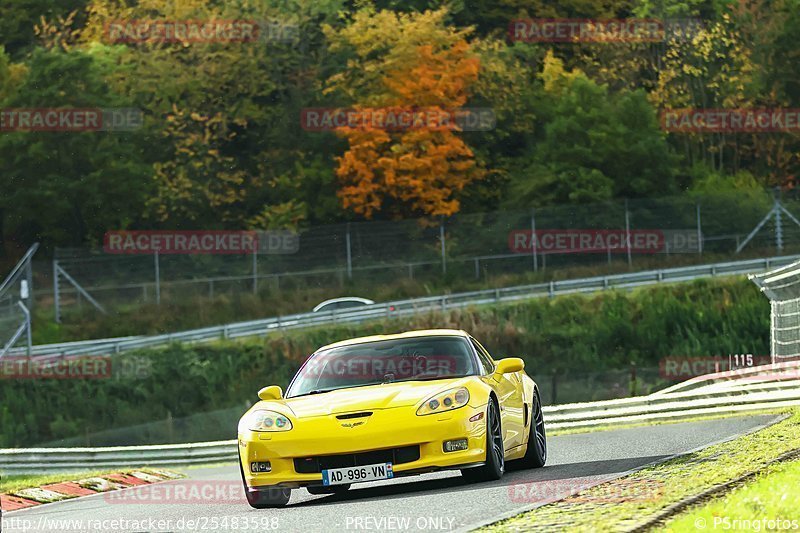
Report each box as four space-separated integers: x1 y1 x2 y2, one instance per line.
508 18 703 43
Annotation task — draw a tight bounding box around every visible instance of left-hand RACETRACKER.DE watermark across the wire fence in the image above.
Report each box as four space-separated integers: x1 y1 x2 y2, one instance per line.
103 230 300 255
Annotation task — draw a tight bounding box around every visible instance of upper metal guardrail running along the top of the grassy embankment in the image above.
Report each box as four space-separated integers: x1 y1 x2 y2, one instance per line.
11 255 800 356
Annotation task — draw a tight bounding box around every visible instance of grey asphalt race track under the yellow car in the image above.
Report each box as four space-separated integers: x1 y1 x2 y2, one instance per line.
3 415 777 532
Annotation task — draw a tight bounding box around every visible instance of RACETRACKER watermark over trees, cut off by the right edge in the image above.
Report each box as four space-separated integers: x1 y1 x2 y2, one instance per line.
661 108 800 133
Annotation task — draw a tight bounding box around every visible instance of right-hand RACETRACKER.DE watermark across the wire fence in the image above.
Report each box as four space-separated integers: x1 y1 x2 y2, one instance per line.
508 229 700 254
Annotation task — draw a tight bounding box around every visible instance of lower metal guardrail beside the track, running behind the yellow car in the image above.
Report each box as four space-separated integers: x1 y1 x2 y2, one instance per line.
0 363 800 474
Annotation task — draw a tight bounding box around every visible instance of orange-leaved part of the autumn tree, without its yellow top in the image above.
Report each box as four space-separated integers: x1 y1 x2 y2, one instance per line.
326 13 484 218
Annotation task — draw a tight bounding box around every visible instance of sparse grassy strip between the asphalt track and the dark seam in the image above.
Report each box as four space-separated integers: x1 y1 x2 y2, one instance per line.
483 410 800 532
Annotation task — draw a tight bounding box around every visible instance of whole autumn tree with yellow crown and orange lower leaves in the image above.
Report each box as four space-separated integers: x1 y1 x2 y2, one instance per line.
327 9 483 218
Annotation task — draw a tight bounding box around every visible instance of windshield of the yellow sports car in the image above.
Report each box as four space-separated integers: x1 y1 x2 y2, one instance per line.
286 336 478 398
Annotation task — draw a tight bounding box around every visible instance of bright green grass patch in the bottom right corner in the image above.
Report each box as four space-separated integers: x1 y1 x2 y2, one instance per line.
661 460 800 531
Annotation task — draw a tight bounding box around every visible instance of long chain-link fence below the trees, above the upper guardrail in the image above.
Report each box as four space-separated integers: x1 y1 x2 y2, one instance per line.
43 189 800 320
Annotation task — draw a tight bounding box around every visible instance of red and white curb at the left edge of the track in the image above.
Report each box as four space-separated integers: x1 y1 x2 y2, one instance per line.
0 468 184 511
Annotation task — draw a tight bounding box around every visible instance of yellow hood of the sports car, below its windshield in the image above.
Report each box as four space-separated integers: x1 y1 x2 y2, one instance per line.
261 377 471 418
